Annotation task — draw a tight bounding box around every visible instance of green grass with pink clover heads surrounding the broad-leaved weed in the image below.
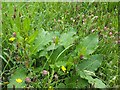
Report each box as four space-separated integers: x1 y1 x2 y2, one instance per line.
1 2 119 88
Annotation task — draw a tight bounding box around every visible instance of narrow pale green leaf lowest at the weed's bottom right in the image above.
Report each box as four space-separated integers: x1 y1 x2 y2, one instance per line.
79 71 106 88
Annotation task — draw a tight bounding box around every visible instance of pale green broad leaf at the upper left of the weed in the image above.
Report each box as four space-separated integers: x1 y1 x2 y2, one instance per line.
30 30 53 54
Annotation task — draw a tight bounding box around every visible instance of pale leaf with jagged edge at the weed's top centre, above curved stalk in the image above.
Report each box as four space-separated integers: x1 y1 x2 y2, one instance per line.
59 31 77 48
